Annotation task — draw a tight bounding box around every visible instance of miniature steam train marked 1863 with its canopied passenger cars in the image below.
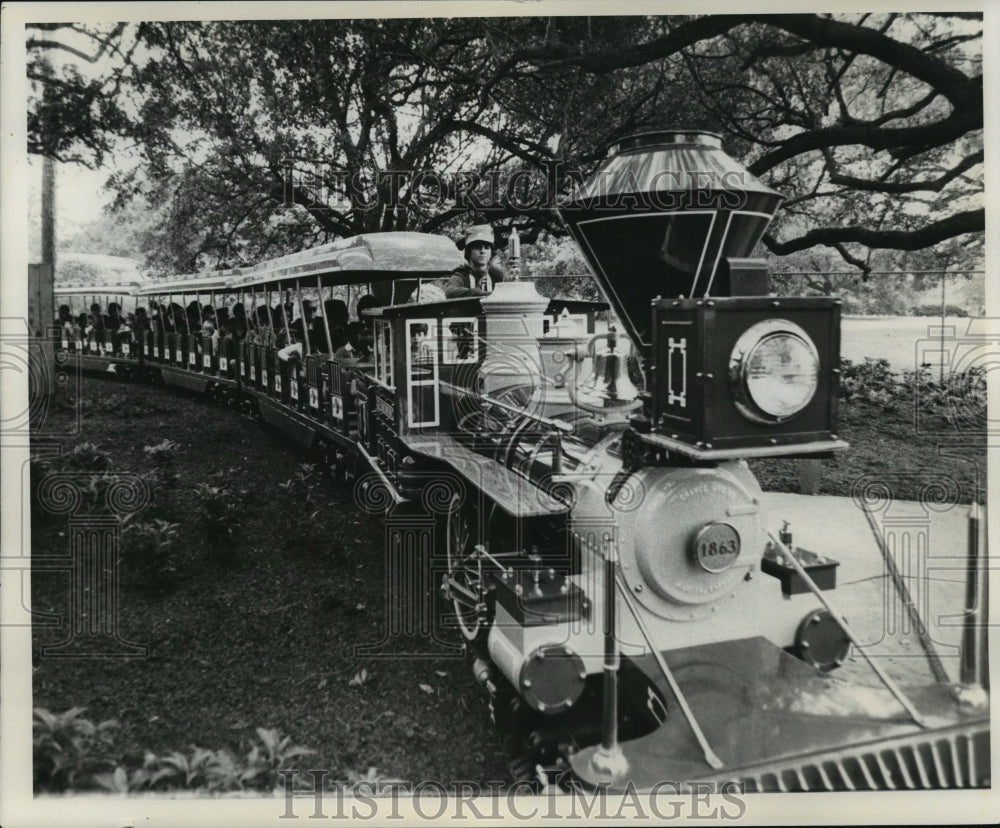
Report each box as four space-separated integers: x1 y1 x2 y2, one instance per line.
52 131 989 791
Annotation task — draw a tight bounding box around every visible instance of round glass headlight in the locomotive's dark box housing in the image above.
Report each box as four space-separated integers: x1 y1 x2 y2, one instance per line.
729 319 819 425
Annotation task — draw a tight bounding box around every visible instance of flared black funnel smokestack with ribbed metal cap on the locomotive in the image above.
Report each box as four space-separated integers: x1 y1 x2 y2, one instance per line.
559 130 781 350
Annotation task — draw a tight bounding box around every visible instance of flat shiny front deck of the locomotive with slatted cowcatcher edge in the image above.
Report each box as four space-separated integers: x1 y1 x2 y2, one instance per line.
569 637 990 791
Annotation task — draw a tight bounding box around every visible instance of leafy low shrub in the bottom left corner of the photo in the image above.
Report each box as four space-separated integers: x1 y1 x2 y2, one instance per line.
31 707 118 793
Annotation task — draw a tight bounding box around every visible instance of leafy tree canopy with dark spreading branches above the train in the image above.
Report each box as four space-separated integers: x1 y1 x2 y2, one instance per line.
29 13 984 272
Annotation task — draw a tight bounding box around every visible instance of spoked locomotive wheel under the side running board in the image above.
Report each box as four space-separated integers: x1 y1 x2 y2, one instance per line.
445 494 486 641
